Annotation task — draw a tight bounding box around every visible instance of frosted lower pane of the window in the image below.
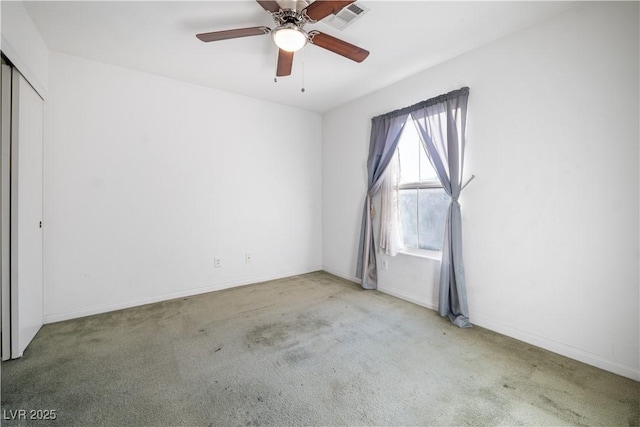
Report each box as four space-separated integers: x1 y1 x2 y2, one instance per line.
418 188 450 251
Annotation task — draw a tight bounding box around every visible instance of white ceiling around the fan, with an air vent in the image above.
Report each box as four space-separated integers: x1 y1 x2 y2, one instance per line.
25 0 573 112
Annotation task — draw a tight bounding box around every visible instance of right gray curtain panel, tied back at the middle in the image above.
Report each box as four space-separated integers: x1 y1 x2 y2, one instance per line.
411 87 472 328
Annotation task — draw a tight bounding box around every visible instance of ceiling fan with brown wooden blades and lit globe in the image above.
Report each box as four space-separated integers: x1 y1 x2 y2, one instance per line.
196 0 369 77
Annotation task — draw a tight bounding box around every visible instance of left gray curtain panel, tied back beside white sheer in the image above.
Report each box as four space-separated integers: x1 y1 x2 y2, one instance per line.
356 110 409 289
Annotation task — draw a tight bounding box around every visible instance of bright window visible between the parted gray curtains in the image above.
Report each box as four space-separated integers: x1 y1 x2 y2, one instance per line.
396 116 450 251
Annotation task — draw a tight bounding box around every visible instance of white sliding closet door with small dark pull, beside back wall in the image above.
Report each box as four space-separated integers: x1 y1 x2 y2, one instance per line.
11 69 44 358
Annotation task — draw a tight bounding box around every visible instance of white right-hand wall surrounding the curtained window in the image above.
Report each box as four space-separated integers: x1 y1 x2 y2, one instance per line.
323 2 640 379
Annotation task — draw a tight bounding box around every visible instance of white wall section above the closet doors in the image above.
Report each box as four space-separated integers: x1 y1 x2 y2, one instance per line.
0 1 49 98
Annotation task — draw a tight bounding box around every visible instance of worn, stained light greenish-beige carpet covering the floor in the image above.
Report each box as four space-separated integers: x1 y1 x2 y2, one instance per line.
2 272 640 426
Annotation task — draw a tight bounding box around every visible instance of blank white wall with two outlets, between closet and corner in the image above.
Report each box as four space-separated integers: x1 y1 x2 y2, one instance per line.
45 53 322 322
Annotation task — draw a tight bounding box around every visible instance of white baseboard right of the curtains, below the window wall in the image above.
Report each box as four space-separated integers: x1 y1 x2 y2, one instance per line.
471 316 640 381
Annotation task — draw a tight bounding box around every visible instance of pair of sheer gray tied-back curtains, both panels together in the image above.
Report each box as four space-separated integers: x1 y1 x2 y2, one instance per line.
356 87 471 328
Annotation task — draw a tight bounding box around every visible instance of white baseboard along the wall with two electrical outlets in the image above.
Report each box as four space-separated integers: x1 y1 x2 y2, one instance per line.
44 266 322 324
